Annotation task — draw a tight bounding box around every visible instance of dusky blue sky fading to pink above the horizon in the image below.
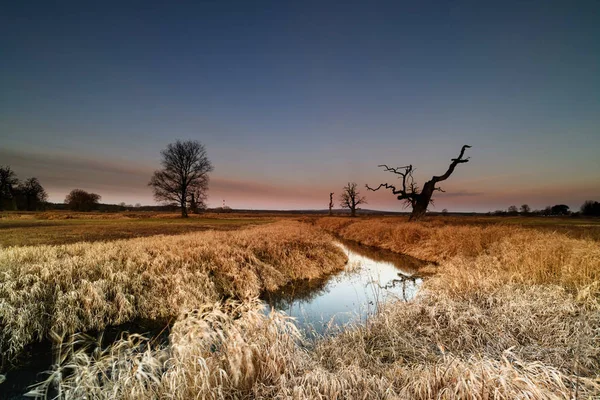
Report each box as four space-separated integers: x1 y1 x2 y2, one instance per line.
0 0 600 211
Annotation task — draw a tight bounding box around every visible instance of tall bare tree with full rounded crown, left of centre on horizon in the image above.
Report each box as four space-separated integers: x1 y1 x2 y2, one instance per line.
148 140 213 218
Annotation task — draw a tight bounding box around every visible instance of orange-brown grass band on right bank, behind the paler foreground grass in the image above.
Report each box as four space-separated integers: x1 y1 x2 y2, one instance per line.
316 218 600 291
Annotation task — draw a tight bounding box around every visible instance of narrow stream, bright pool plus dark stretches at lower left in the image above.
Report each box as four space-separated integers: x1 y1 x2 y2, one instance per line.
0 241 426 399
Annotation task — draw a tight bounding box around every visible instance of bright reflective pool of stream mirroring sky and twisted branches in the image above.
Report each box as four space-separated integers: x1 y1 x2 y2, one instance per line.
263 241 424 336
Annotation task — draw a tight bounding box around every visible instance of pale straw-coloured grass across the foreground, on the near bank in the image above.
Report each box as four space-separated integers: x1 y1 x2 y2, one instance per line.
31 287 600 399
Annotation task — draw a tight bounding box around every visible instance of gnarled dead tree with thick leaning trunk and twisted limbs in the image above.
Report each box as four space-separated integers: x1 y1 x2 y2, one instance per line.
367 145 471 221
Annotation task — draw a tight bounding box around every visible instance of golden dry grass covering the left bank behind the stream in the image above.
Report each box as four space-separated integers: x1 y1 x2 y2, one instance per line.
0 222 345 364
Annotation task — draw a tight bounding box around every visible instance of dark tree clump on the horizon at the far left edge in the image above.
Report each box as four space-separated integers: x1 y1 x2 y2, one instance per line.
0 166 48 211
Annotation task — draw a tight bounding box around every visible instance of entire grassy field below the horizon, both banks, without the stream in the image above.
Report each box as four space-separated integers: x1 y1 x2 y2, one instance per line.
0 213 600 399
